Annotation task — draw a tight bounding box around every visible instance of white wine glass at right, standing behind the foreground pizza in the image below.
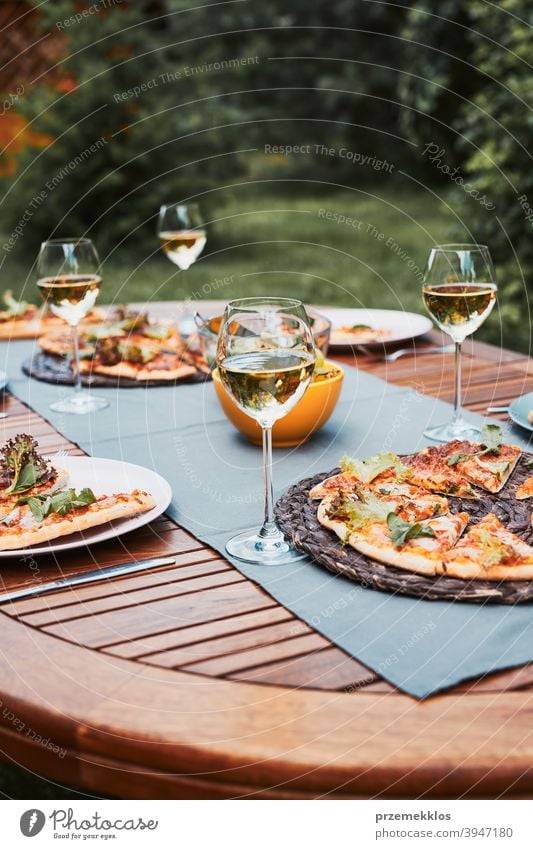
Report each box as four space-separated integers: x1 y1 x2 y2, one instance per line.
422 244 497 442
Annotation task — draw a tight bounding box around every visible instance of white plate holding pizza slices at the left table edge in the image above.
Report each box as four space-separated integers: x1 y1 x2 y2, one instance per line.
0 457 172 558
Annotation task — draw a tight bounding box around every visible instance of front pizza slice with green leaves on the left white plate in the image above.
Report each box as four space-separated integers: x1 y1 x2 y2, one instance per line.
0 489 156 551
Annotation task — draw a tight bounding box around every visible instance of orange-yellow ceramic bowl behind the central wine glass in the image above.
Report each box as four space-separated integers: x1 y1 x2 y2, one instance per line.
213 360 344 448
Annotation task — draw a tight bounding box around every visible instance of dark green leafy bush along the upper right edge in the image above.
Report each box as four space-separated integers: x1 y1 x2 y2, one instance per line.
402 0 533 351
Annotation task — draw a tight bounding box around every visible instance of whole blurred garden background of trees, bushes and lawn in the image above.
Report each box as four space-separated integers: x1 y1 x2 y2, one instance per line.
0 0 533 351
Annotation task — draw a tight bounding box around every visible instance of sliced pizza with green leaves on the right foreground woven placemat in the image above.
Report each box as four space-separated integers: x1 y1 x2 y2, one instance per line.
309 425 533 581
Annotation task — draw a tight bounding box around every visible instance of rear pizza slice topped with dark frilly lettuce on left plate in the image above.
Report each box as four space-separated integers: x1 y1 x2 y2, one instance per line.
0 433 69 506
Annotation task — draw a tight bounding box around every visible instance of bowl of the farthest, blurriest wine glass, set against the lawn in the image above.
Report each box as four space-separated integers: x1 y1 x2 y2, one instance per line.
157 203 207 271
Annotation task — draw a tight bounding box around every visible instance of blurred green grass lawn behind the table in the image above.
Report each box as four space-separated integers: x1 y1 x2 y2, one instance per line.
0 183 462 310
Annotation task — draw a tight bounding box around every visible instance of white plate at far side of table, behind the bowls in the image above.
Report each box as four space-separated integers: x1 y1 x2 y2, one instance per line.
317 307 433 349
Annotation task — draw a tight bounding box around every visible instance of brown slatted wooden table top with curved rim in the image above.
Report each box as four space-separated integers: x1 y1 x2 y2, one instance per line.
0 314 533 798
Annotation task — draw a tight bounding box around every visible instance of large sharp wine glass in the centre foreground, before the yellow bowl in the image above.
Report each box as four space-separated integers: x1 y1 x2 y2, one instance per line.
216 298 315 565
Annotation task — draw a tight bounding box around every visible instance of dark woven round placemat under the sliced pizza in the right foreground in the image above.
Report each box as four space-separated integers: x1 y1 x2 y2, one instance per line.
276 454 533 604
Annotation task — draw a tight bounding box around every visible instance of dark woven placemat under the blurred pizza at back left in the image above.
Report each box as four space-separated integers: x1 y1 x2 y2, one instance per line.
22 352 210 389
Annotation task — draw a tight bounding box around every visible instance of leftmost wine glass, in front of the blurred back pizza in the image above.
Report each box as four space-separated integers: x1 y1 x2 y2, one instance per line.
37 238 109 415
